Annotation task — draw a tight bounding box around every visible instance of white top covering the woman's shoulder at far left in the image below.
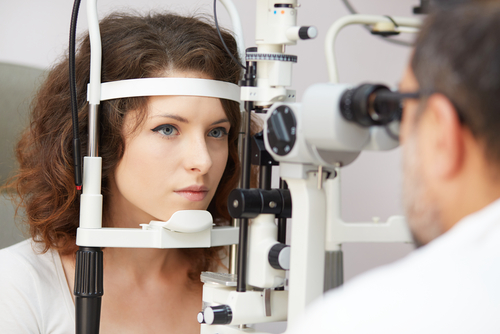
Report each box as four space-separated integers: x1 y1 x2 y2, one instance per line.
0 239 74 333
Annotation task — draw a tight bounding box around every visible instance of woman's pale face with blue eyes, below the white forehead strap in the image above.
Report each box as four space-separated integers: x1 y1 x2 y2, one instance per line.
110 83 230 225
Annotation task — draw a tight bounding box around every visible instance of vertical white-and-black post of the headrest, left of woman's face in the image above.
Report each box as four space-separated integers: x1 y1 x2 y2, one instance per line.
74 0 104 328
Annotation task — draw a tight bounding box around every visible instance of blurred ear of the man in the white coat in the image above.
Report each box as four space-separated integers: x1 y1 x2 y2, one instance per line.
420 93 465 179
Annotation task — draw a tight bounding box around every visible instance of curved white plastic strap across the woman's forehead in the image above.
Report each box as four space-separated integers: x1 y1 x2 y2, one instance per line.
87 78 240 102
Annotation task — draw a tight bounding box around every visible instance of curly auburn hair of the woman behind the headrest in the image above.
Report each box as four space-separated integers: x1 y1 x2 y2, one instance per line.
8 14 249 279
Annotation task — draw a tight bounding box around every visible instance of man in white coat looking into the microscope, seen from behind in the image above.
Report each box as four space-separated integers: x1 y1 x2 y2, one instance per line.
290 2 500 334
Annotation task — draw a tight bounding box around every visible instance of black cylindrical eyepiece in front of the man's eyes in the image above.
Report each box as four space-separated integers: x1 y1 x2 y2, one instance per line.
340 84 403 127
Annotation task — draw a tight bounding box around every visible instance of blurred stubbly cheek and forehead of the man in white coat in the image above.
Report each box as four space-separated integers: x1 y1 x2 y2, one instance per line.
400 67 442 246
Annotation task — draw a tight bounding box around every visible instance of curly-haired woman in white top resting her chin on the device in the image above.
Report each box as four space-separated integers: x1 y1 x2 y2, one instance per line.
0 14 248 333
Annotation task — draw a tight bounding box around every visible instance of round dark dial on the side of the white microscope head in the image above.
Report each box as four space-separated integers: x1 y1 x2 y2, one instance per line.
267 105 297 156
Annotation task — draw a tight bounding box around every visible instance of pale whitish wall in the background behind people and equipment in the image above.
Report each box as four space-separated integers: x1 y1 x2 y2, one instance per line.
0 0 418 324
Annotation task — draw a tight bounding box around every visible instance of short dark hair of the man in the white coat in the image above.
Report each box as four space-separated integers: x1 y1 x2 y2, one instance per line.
411 1 500 163
